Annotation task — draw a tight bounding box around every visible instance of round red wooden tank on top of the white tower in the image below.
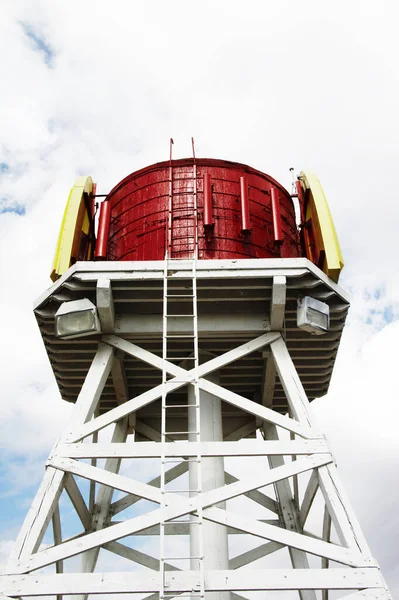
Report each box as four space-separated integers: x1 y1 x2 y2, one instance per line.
107 158 301 260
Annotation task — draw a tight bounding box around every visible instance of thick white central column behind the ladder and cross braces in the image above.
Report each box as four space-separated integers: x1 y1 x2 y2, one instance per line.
188 372 230 600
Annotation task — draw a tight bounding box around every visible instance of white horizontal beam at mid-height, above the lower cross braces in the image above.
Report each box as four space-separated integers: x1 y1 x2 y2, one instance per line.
57 439 329 458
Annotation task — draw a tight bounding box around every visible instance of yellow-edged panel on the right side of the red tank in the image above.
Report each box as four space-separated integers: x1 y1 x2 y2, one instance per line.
299 171 344 282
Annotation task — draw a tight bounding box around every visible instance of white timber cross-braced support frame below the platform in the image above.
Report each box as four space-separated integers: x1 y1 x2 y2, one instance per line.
0 332 390 599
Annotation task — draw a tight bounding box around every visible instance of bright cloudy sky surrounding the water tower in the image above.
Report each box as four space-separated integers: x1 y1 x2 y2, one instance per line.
0 0 399 595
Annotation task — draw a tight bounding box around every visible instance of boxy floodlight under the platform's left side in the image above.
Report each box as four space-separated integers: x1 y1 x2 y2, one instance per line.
55 298 101 338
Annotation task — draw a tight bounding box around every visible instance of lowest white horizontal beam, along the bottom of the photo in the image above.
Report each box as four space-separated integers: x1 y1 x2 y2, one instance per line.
0 568 384 597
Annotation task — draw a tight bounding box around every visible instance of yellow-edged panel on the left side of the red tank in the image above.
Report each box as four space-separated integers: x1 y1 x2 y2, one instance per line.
50 177 93 281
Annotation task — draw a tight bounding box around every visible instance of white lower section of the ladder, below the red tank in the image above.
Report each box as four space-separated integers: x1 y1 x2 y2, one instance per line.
159 257 205 600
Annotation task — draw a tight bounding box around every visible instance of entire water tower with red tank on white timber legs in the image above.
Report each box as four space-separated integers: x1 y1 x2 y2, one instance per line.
0 146 391 600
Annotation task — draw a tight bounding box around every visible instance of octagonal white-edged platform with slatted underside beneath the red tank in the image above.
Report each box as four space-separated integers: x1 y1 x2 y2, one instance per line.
35 258 349 436
